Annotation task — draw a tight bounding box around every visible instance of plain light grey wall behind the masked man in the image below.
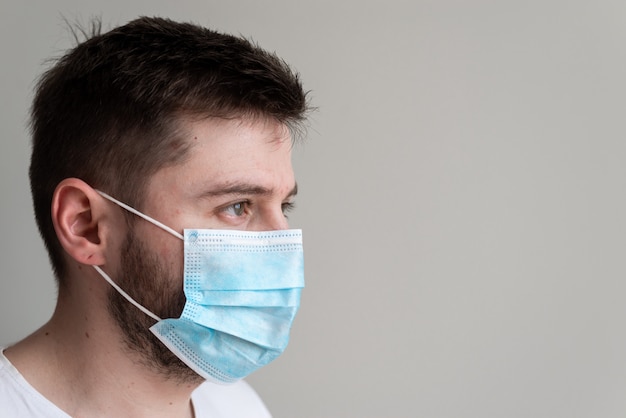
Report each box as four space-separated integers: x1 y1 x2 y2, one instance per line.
0 0 626 418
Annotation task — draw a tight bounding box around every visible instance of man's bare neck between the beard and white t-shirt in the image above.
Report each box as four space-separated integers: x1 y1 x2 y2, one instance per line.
5 286 201 417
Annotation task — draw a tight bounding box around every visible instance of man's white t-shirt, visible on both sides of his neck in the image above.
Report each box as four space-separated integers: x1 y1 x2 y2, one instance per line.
0 348 271 418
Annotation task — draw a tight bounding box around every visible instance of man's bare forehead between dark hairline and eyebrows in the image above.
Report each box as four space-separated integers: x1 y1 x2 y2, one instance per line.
148 118 295 198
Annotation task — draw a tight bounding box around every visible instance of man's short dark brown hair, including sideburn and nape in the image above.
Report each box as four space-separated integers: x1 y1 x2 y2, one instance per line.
29 17 308 283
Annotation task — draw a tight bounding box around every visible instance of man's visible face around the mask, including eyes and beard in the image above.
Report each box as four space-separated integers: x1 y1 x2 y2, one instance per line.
109 119 296 381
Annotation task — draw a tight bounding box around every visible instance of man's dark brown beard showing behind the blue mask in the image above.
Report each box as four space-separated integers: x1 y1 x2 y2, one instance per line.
108 227 204 384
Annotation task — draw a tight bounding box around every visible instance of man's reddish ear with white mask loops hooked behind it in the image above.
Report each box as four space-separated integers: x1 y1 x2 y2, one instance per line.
51 178 114 265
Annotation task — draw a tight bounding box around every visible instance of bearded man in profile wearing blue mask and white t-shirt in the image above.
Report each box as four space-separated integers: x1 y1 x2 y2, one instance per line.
0 14 307 418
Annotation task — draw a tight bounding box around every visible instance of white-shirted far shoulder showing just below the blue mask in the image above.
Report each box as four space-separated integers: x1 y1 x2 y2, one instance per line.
191 380 271 418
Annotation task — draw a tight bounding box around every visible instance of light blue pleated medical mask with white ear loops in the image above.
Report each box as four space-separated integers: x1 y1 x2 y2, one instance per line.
94 192 304 383
